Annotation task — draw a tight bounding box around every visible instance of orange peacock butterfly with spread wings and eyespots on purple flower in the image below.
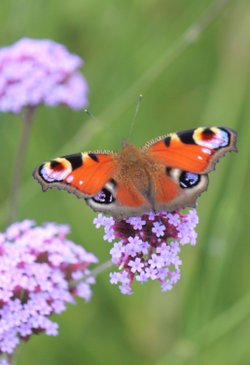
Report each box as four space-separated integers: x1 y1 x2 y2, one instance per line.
33 127 237 219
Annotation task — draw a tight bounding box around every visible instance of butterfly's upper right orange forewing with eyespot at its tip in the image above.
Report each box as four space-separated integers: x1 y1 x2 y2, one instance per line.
143 127 237 174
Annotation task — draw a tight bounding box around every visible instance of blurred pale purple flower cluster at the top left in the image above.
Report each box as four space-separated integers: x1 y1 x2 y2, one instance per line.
0 38 88 113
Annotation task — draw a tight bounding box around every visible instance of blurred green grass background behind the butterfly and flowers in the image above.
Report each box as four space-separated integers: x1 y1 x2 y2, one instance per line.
0 0 250 365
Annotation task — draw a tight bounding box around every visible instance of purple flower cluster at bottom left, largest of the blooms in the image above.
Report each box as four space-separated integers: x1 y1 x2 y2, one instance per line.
0 220 97 354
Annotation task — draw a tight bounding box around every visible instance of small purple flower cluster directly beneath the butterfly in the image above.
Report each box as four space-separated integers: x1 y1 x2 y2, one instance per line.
94 209 198 294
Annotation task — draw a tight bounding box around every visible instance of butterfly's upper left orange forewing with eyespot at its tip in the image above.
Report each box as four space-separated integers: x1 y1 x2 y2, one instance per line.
33 152 116 198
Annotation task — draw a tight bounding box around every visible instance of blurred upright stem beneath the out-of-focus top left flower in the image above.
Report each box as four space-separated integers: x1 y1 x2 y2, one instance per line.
9 107 34 223
